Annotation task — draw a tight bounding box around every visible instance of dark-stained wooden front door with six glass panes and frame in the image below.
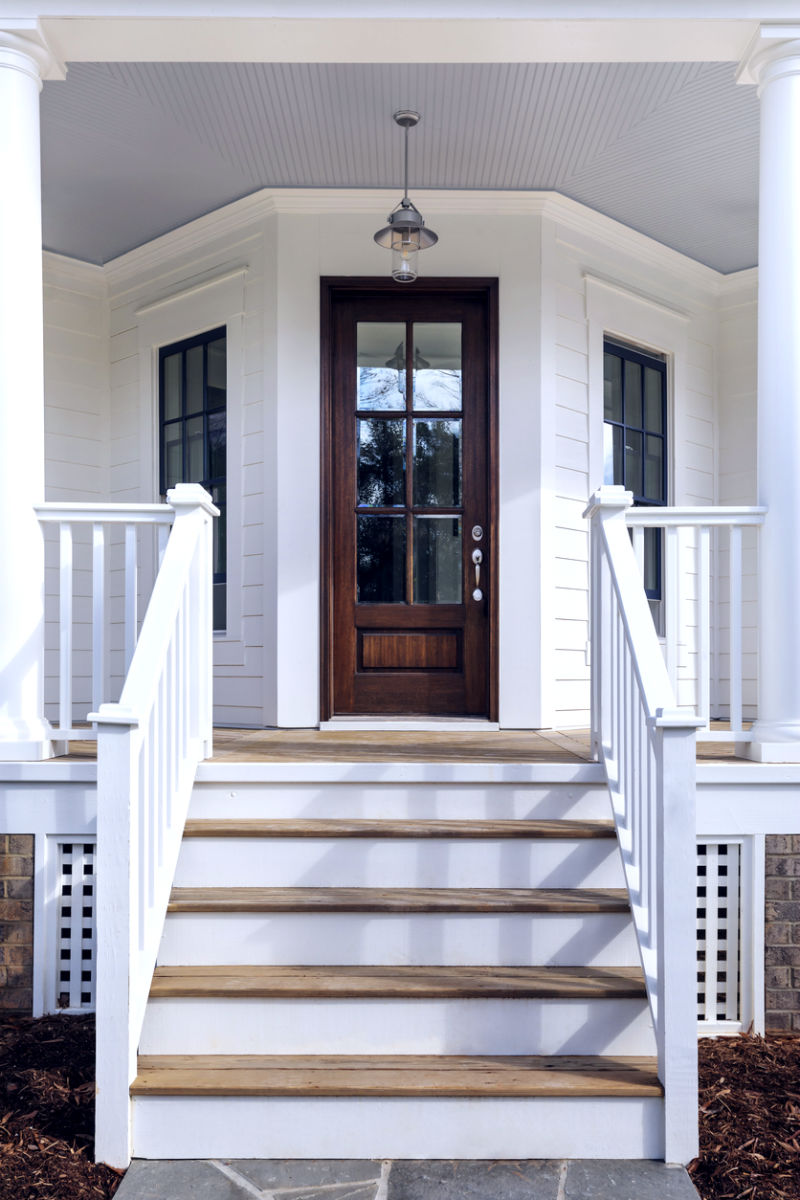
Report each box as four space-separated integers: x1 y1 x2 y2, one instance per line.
324 281 495 716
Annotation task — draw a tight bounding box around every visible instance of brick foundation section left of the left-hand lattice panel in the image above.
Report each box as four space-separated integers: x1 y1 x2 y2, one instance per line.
0 833 34 1015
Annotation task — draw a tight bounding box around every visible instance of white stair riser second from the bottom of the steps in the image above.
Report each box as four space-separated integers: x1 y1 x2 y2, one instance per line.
139 997 655 1055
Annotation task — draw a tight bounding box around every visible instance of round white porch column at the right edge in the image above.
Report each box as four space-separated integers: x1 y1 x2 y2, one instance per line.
739 25 800 762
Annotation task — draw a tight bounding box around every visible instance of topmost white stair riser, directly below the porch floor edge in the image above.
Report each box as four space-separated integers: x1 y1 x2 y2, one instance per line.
190 767 612 821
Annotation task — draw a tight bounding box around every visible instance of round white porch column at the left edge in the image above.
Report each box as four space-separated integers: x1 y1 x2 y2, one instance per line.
0 28 61 761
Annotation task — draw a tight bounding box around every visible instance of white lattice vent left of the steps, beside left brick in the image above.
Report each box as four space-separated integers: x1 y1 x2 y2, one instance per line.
55 841 96 1010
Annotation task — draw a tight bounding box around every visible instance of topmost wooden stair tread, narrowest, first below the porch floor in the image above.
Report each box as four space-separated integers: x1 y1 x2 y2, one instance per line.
184 817 615 840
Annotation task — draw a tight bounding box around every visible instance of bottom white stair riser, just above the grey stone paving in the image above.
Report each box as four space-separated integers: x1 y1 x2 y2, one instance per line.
133 1096 663 1159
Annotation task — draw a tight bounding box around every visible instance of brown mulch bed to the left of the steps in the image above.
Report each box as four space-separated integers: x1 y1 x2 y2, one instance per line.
0 1016 124 1200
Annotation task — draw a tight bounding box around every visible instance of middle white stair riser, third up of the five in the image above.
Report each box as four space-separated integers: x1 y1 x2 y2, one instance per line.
158 912 639 966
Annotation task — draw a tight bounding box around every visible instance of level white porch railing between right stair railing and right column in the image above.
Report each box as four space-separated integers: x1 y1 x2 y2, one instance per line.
626 508 766 742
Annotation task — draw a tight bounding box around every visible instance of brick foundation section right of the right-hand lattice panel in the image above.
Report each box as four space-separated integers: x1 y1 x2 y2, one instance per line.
764 834 800 1033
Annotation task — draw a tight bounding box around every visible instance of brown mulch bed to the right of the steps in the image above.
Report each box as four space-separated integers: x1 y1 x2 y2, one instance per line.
688 1034 800 1200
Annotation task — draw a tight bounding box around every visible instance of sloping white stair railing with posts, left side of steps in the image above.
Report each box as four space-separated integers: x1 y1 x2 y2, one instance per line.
90 484 217 1166
